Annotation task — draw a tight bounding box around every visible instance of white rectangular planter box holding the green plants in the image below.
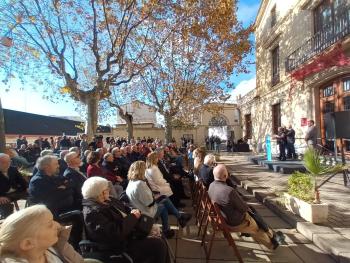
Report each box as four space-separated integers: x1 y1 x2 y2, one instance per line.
284 193 328 223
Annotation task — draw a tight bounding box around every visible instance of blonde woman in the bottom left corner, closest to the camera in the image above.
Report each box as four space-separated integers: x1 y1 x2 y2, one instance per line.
0 205 84 263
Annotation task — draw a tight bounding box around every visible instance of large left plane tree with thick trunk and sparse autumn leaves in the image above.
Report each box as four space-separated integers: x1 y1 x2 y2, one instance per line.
0 0 174 139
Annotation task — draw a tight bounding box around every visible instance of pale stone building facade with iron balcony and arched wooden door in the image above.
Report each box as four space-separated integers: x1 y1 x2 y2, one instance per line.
238 0 350 155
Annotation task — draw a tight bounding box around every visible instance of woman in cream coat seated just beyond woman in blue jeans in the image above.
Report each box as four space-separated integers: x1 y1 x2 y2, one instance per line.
145 152 173 197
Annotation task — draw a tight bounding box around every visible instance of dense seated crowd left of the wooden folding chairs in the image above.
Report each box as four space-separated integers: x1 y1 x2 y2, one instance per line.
0 135 200 262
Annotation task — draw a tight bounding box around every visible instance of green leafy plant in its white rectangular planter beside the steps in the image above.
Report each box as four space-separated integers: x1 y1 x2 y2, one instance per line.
284 149 344 223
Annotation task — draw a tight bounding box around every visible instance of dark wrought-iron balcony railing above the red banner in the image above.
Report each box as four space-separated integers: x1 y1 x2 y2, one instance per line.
285 6 350 72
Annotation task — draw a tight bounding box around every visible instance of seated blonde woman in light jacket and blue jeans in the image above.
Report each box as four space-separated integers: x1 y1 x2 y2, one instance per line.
126 161 191 238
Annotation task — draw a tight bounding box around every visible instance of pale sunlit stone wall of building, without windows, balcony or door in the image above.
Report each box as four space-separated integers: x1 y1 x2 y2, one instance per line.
238 0 350 155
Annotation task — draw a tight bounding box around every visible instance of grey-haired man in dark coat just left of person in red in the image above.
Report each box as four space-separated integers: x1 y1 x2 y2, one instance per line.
63 152 86 210
